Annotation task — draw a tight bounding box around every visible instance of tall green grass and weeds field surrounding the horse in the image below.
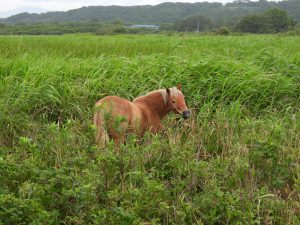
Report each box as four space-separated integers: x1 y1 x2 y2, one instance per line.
0 35 300 225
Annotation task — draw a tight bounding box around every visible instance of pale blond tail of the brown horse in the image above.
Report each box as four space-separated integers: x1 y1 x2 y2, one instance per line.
94 109 109 147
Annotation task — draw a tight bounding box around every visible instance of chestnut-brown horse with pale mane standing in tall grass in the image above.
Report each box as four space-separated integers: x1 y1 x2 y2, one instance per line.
94 84 190 147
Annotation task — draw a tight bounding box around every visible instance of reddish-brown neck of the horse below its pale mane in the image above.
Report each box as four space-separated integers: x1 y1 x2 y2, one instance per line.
136 92 171 119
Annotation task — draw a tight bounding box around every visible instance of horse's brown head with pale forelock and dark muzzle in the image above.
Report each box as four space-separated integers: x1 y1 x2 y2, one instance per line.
166 84 191 119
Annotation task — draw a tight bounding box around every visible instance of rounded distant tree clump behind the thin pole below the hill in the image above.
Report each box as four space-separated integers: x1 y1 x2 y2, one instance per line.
175 15 212 32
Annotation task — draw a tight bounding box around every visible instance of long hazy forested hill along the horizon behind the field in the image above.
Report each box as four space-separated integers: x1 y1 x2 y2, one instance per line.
0 0 300 25
